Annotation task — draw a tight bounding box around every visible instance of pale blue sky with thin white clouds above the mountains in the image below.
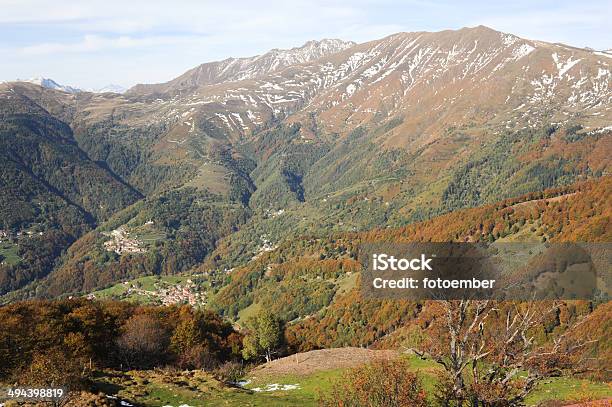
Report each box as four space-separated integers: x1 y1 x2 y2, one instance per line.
0 0 612 89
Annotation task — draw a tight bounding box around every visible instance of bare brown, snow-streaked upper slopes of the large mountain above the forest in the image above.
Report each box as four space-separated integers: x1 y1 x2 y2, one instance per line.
112 27 612 212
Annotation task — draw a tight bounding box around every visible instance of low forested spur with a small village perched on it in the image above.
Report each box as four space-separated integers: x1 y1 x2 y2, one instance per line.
42 189 249 296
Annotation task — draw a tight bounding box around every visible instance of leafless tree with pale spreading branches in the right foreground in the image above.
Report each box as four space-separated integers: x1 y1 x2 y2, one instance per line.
412 300 588 406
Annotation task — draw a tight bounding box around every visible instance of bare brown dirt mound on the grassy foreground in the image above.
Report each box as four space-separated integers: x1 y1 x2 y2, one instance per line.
251 348 399 377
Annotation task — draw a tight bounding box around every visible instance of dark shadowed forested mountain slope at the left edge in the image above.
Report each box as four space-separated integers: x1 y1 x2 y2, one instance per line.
0 83 140 293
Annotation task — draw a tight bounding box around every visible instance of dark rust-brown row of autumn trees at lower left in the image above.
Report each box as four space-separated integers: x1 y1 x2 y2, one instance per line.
0 298 242 388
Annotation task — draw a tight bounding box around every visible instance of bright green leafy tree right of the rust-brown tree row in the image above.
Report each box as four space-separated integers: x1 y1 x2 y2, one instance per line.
242 311 283 362
